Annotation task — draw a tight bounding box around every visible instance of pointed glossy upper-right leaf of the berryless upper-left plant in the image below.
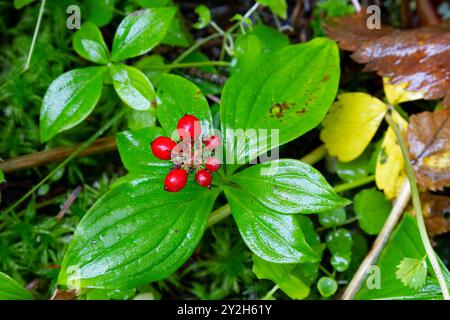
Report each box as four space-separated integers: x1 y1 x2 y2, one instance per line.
112 7 176 61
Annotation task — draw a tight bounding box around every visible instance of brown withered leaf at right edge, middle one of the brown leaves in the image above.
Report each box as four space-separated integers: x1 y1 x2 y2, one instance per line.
408 108 450 190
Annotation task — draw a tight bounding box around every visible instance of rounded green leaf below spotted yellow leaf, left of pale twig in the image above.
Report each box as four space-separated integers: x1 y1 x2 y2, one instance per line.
354 188 392 235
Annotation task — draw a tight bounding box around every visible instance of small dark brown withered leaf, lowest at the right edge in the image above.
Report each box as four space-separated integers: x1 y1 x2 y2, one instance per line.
420 193 450 238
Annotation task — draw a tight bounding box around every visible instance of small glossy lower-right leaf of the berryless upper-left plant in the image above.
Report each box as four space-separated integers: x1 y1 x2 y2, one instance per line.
109 64 156 110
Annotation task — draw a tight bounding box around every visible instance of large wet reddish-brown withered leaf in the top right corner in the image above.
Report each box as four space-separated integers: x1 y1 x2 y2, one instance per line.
324 14 450 106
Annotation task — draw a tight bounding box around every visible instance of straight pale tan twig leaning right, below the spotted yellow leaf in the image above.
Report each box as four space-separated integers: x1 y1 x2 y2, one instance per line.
341 181 411 300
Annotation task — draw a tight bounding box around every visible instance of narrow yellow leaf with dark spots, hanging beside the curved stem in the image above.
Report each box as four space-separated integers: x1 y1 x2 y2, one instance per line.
375 112 408 199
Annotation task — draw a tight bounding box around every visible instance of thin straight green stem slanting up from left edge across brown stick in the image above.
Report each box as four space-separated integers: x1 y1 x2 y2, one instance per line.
0 109 126 220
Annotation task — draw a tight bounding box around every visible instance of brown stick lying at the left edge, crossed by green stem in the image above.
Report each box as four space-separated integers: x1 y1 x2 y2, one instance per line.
0 136 116 173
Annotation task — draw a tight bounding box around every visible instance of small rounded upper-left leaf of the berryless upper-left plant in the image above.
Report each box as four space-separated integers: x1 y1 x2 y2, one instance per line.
72 22 109 64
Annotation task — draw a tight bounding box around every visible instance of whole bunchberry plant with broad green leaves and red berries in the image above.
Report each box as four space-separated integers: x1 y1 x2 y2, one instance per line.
59 35 349 289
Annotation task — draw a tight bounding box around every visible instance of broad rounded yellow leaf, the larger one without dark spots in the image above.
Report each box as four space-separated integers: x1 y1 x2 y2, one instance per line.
320 92 387 162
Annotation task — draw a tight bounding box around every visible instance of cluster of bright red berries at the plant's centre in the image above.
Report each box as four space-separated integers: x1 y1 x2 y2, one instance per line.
151 114 220 192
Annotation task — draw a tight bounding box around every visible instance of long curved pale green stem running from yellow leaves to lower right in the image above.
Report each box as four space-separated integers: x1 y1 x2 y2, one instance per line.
386 114 450 300
